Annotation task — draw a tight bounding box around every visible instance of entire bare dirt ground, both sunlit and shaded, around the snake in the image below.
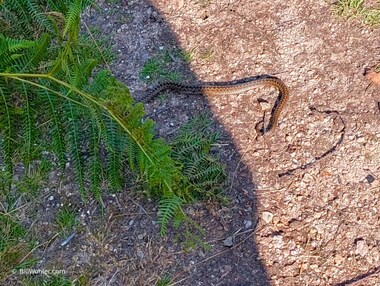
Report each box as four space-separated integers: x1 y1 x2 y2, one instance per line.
5 0 380 286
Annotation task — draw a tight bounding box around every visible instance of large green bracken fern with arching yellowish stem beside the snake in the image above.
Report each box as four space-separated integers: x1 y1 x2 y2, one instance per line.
0 0 223 235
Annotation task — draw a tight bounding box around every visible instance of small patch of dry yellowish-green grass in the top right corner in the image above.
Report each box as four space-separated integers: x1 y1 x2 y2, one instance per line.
334 0 380 26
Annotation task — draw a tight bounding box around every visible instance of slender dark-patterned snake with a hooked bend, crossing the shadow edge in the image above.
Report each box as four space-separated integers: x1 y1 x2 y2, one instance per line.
142 75 289 135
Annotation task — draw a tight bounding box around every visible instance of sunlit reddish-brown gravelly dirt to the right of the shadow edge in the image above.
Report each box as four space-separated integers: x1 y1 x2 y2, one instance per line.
146 1 380 285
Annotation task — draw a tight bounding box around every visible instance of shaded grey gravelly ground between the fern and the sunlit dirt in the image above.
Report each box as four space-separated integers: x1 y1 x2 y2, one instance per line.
3 1 269 286
